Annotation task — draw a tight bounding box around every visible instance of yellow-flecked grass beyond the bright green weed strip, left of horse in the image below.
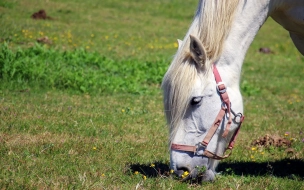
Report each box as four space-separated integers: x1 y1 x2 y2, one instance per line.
0 0 197 61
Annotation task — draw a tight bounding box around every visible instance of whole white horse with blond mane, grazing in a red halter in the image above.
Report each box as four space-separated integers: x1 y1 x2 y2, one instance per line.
162 0 304 180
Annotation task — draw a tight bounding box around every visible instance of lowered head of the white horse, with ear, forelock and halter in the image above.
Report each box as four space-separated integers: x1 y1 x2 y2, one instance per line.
162 35 242 180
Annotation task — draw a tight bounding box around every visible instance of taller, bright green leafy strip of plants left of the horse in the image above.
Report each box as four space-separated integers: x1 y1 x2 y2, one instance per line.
0 43 168 94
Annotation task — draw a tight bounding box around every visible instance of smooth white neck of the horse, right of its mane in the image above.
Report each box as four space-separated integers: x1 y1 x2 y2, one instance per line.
217 0 272 88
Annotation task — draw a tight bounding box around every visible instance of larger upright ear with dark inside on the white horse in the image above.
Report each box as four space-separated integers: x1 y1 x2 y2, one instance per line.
190 35 206 66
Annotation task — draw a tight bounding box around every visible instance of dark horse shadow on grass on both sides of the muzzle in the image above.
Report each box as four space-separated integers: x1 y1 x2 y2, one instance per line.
127 159 304 180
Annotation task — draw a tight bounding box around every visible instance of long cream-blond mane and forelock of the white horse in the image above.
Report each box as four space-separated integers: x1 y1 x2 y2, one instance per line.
162 0 239 143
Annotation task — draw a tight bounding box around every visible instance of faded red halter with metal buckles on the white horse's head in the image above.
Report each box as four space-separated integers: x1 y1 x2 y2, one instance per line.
171 64 245 160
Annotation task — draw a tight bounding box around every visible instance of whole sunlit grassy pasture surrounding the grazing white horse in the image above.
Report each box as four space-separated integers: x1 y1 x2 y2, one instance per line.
0 0 304 189
